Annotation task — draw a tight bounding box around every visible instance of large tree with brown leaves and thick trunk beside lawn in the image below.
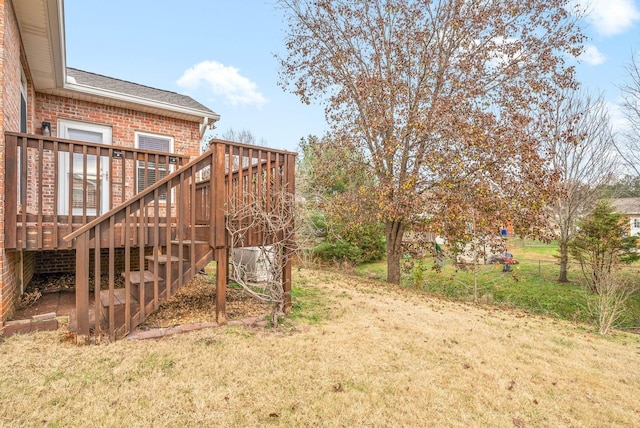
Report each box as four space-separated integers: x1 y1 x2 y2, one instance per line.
277 0 583 282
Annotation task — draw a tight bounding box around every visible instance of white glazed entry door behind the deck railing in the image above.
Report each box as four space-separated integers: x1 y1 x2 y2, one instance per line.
58 119 112 216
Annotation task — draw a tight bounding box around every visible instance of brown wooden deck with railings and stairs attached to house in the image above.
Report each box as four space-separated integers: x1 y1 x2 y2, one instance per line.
5 137 295 342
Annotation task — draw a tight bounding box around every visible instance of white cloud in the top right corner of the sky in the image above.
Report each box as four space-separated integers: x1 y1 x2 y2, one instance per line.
587 0 640 36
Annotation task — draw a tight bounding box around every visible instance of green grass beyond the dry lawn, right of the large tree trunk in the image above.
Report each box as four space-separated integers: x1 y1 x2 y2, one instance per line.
356 239 640 328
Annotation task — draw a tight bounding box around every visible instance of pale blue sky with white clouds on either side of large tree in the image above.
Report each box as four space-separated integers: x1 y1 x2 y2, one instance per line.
65 0 640 154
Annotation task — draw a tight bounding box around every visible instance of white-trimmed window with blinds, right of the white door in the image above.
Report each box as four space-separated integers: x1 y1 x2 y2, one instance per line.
135 132 173 200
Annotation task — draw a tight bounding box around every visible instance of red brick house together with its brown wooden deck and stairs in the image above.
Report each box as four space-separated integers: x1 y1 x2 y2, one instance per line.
0 0 293 338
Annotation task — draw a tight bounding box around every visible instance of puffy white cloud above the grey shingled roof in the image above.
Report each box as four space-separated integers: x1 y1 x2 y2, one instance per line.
177 61 267 107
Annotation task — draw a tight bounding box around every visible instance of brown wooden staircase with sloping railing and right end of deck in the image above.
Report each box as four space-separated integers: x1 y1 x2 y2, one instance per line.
64 140 295 342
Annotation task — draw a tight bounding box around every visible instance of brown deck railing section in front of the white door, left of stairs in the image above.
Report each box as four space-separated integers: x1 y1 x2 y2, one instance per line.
4 132 188 250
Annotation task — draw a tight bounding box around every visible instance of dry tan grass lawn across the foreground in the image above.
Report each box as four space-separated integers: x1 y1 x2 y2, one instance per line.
0 271 640 427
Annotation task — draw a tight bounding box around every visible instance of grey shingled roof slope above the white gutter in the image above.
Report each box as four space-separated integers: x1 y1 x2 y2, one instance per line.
67 67 216 116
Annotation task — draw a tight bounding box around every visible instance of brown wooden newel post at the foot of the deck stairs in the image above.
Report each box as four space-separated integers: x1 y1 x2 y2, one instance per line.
76 233 90 345
